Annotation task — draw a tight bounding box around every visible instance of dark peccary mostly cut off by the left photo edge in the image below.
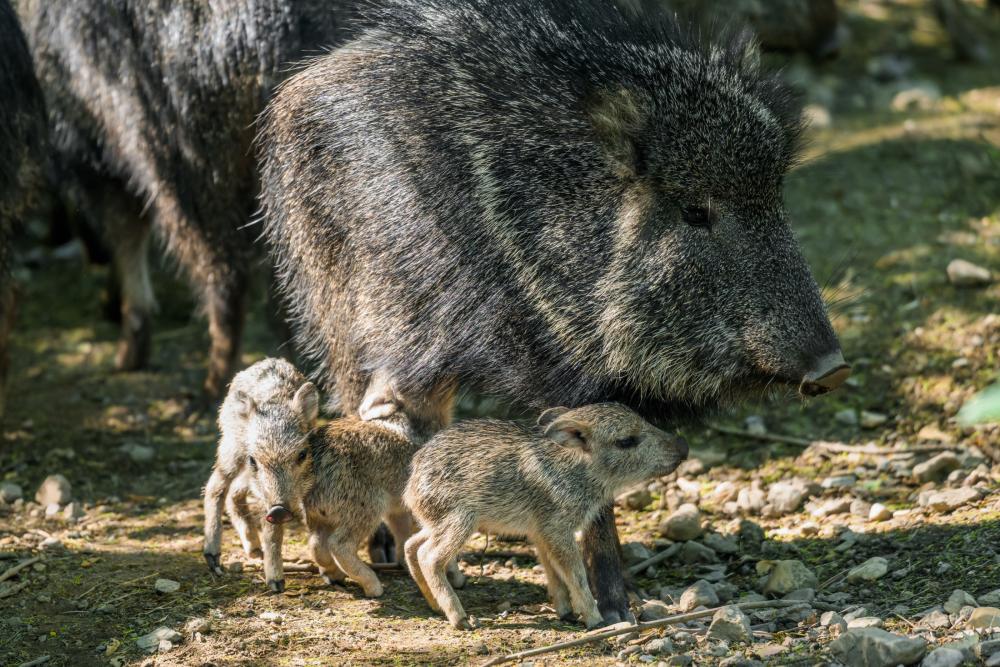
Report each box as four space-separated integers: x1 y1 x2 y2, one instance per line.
0 0 45 419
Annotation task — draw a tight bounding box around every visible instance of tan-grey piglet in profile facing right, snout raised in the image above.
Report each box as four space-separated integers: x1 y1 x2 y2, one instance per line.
404 403 687 629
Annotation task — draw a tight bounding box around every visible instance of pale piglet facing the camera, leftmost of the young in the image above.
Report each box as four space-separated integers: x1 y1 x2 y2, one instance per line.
204 359 319 590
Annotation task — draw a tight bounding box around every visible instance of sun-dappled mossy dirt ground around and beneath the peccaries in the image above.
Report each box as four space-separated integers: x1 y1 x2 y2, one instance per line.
0 1 1000 665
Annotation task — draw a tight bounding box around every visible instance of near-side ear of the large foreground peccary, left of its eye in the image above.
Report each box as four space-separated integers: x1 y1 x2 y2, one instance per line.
587 86 647 178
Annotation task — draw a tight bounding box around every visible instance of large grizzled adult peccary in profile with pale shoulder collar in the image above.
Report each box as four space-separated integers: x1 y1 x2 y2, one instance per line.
261 0 850 621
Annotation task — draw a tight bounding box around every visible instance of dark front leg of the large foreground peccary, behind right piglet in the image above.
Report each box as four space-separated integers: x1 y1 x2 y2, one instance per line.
583 505 632 625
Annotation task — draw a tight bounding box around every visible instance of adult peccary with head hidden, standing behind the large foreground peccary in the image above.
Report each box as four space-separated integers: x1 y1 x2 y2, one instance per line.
18 0 350 396
